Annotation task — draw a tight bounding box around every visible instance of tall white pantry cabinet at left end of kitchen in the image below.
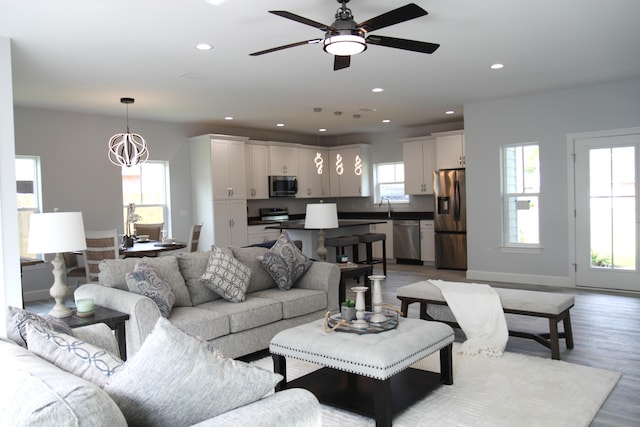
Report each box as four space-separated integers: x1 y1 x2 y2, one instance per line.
189 134 249 248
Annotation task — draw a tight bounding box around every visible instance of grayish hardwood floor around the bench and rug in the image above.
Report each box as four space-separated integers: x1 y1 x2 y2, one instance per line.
347 263 640 427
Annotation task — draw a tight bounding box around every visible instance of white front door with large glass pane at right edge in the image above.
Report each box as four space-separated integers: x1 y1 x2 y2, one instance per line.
573 129 640 291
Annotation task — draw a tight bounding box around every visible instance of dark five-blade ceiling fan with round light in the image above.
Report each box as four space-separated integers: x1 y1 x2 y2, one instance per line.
249 0 440 71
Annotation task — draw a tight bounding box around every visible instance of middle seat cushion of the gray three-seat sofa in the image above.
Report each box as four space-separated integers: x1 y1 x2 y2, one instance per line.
198 298 282 333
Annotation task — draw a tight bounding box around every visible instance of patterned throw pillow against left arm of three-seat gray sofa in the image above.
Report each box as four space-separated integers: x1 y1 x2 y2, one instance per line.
126 262 176 317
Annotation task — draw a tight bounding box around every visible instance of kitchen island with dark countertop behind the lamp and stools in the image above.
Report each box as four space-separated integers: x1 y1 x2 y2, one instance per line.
265 219 385 262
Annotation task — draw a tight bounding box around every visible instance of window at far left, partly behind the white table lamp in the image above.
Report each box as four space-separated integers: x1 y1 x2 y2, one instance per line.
15 156 42 258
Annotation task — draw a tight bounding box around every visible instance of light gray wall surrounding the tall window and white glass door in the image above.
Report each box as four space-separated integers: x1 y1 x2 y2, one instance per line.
464 79 640 286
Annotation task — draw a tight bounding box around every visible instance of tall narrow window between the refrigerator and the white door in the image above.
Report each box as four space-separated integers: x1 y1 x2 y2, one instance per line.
502 143 540 247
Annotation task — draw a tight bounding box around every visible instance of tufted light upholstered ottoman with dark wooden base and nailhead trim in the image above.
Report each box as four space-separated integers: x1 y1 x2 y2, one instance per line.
269 318 454 426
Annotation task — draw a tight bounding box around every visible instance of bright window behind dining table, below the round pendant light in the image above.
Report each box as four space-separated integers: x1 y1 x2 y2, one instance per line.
122 161 171 232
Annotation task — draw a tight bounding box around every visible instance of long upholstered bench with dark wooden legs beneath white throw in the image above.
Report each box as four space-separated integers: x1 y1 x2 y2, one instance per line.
397 281 575 359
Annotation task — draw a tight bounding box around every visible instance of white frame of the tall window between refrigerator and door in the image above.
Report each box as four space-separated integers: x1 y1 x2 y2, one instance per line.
500 142 542 253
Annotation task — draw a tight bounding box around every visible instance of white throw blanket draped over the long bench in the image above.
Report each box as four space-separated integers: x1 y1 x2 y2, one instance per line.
429 280 509 357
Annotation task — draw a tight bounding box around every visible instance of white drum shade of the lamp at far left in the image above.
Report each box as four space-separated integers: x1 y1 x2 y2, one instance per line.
27 212 87 254
